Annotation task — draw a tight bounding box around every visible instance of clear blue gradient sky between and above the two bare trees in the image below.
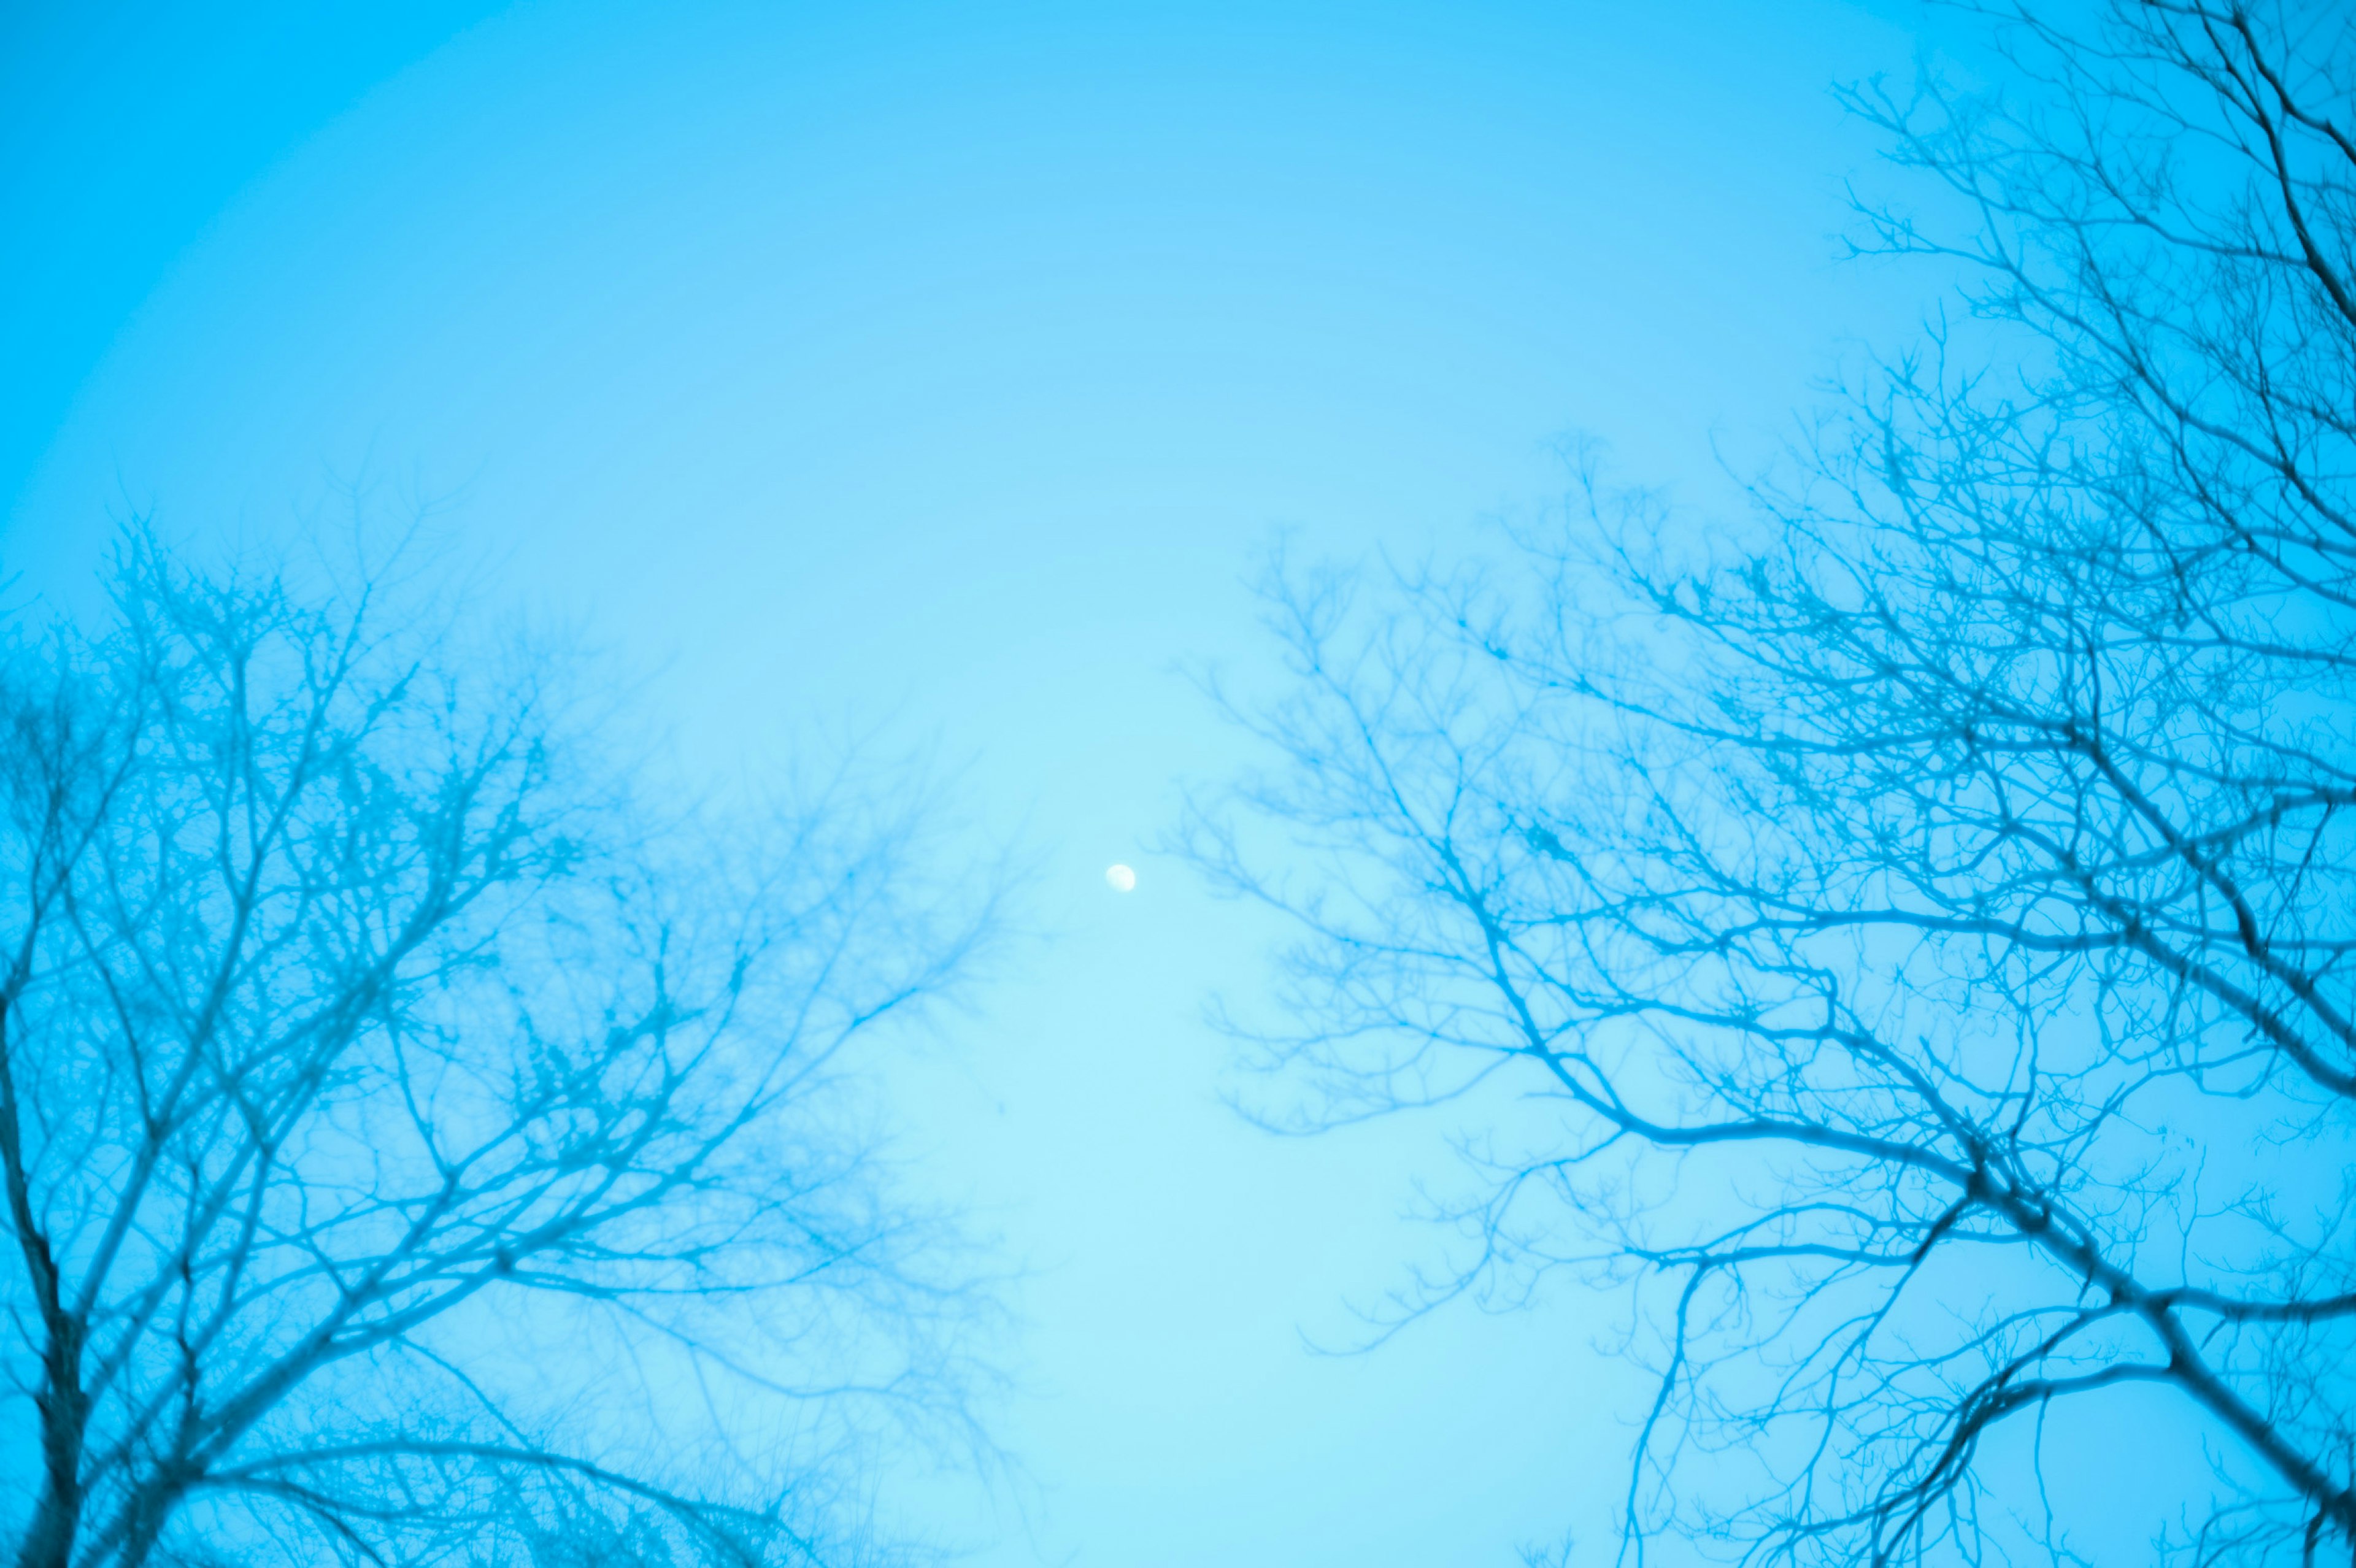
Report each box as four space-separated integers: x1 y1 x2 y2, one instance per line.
0 0 1927 1568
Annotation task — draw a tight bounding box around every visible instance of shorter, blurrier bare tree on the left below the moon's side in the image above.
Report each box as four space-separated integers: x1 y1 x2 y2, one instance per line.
0 539 990 1568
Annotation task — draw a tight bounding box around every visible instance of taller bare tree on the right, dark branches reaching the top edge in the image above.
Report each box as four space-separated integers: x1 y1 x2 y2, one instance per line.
1195 0 2356 1563
